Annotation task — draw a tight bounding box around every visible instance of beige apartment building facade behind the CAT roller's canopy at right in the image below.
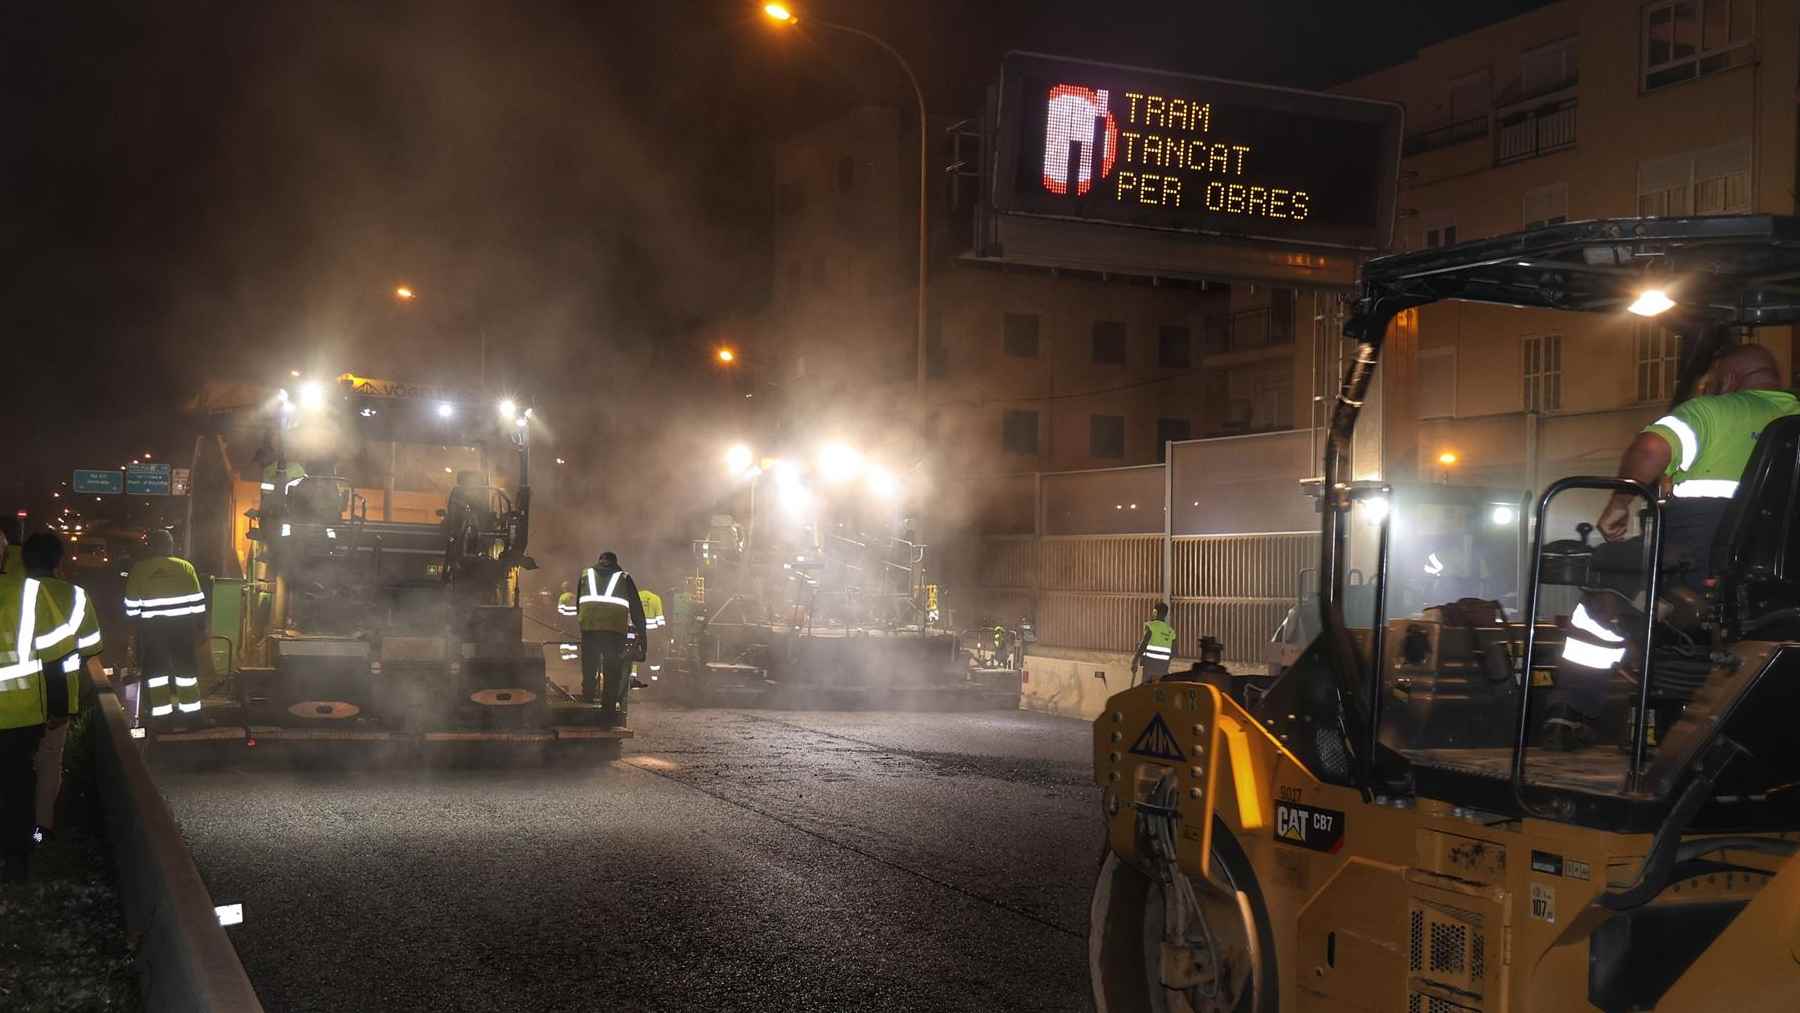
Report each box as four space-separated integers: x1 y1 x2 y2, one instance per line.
1339 0 1800 488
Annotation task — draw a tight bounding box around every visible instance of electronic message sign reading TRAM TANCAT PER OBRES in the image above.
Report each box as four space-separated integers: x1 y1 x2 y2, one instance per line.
994 52 1402 250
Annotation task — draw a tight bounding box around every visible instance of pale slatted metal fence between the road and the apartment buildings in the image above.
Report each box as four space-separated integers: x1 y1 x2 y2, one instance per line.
952 444 1319 662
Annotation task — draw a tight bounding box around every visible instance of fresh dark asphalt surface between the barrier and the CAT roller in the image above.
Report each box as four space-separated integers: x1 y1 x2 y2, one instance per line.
157 704 1100 1011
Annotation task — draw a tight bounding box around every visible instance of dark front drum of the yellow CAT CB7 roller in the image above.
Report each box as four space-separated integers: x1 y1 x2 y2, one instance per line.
1087 820 1282 1013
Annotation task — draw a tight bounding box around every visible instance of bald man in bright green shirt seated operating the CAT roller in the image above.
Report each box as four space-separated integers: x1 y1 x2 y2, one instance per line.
1544 345 1800 750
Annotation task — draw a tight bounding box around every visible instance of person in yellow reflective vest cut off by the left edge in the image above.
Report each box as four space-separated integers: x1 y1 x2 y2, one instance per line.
0 518 76 882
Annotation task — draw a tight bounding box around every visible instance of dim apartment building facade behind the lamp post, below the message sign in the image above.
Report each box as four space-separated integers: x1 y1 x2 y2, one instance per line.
770 106 1323 475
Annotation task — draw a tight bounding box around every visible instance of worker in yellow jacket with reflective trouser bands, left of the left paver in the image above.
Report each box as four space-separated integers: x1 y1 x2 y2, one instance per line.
124 527 207 722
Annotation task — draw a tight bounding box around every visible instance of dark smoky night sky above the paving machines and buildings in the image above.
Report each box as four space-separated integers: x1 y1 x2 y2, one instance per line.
0 0 1539 507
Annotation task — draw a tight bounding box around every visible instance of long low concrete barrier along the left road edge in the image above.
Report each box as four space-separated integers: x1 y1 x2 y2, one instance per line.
94 686 263 1013
